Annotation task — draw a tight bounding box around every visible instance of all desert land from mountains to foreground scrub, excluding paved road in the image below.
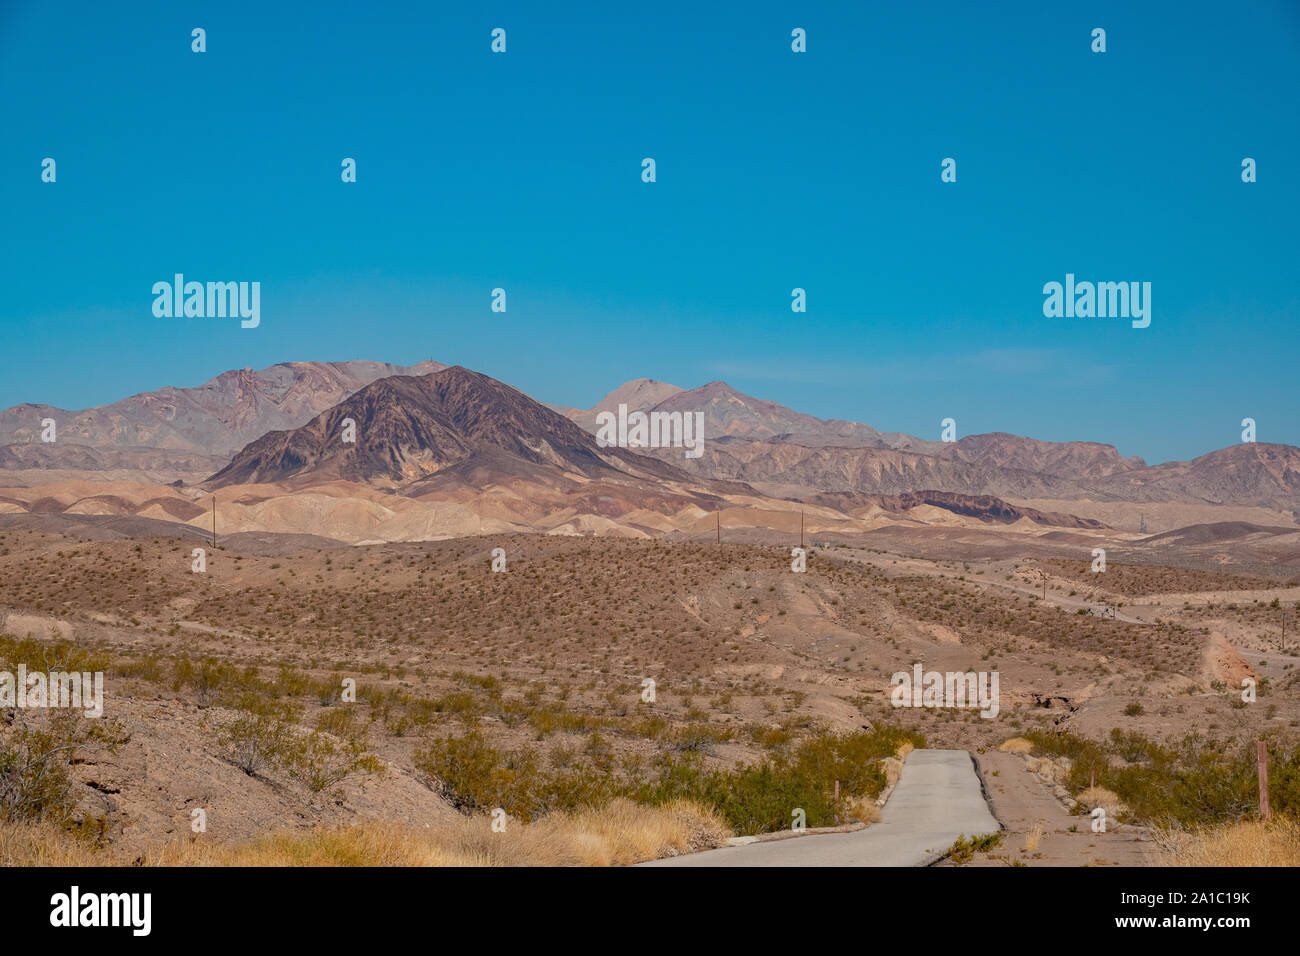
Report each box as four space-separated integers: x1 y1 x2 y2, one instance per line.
0 362 1300 865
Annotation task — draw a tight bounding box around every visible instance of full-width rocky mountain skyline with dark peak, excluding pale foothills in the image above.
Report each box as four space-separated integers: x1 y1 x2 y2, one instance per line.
0 360 1300 510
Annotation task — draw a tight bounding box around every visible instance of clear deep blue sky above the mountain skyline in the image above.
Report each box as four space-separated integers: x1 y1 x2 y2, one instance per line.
0 0 1300 462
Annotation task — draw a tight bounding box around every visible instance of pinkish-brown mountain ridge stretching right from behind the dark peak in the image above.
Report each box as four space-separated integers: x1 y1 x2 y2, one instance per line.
567 378 1300 509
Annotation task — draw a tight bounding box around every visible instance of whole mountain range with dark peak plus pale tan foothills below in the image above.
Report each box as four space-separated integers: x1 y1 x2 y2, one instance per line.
0 362 1300 546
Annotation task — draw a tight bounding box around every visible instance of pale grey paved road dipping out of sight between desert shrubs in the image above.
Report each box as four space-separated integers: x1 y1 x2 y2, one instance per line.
642 750 1000 866
